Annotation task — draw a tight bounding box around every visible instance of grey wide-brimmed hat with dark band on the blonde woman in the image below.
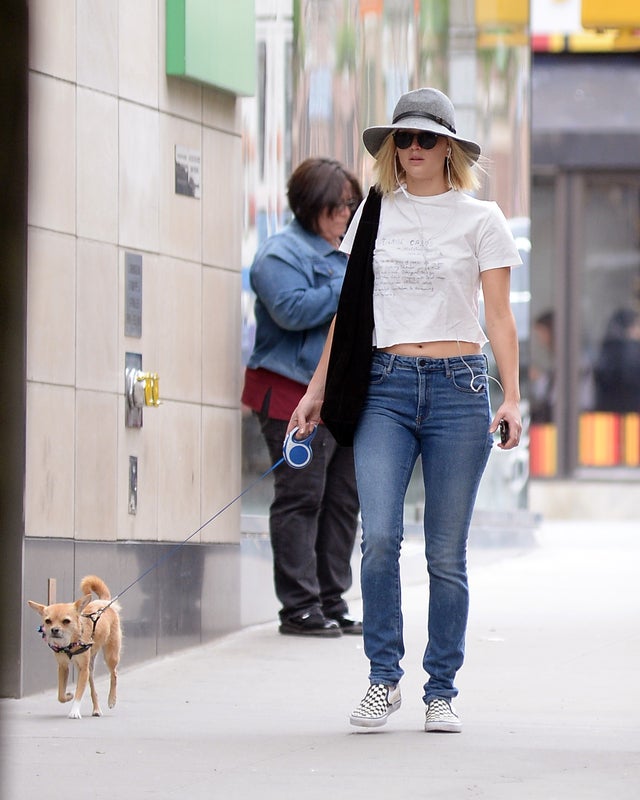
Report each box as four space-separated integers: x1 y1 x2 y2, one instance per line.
362 89 480 161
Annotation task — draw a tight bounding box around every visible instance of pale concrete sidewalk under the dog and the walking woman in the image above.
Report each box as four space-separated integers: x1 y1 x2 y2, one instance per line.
0 522 640 800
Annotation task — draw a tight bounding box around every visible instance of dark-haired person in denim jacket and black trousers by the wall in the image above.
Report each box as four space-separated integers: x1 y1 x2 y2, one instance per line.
242 158 362 637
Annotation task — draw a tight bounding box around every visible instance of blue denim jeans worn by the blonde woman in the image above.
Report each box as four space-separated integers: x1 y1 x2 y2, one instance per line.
354 352 493 703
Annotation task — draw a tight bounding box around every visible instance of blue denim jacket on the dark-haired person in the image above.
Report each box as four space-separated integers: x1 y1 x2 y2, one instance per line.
247 219 347 385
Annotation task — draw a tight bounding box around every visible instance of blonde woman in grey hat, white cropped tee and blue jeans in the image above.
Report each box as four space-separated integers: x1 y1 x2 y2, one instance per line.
289 88 522 732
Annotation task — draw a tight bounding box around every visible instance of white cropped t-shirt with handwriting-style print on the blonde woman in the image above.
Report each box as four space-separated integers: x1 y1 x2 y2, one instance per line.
340 189 522 348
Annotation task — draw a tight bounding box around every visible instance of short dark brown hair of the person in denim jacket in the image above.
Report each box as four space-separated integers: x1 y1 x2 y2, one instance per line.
287 158 362 233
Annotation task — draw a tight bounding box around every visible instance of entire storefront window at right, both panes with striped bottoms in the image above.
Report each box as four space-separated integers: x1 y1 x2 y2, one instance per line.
527 171 640 478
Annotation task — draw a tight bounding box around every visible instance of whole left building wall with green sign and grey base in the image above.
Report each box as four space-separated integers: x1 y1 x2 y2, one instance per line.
2 0 255 695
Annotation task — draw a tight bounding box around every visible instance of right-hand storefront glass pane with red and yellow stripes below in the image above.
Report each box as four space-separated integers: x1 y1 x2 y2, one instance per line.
577 176 640 467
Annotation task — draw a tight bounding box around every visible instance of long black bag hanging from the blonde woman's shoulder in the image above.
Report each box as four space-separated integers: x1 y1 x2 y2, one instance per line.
321 188 382 446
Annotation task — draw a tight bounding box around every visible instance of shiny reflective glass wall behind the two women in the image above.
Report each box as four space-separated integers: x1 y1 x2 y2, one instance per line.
242 0 530 511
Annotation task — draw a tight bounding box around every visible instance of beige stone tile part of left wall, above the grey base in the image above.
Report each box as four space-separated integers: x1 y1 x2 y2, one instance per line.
25 0 242 542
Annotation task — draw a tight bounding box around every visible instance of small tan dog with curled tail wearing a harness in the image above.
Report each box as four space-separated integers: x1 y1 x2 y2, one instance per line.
29 575 122 719
